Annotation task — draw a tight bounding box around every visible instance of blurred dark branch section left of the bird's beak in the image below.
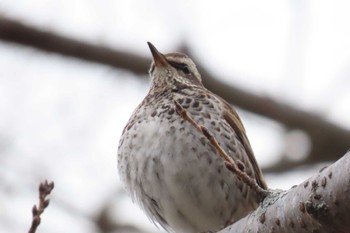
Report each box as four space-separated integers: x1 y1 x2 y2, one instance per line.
0 17 149 74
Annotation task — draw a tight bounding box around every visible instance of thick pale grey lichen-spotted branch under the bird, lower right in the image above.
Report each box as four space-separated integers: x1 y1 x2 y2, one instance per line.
220 152 350 233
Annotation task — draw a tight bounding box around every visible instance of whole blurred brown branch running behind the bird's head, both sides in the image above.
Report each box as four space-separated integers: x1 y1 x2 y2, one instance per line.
0 17 350 171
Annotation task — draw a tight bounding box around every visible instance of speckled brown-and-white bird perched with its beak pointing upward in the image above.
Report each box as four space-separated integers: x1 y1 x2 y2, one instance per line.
117 42 267 233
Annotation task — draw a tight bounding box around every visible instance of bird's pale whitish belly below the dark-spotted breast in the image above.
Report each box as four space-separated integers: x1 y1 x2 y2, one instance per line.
117 117 253 232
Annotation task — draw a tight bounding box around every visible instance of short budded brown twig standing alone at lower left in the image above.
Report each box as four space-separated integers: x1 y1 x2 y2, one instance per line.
28 180 54 233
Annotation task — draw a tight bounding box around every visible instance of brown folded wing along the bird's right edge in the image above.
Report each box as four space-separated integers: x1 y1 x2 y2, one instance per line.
219 97 267 189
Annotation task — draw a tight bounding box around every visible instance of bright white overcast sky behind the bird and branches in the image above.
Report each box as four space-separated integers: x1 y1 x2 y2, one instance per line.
0 0 350 233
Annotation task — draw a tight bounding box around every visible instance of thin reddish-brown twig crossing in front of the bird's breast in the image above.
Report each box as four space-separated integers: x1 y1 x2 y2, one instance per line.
174 100 269 198
